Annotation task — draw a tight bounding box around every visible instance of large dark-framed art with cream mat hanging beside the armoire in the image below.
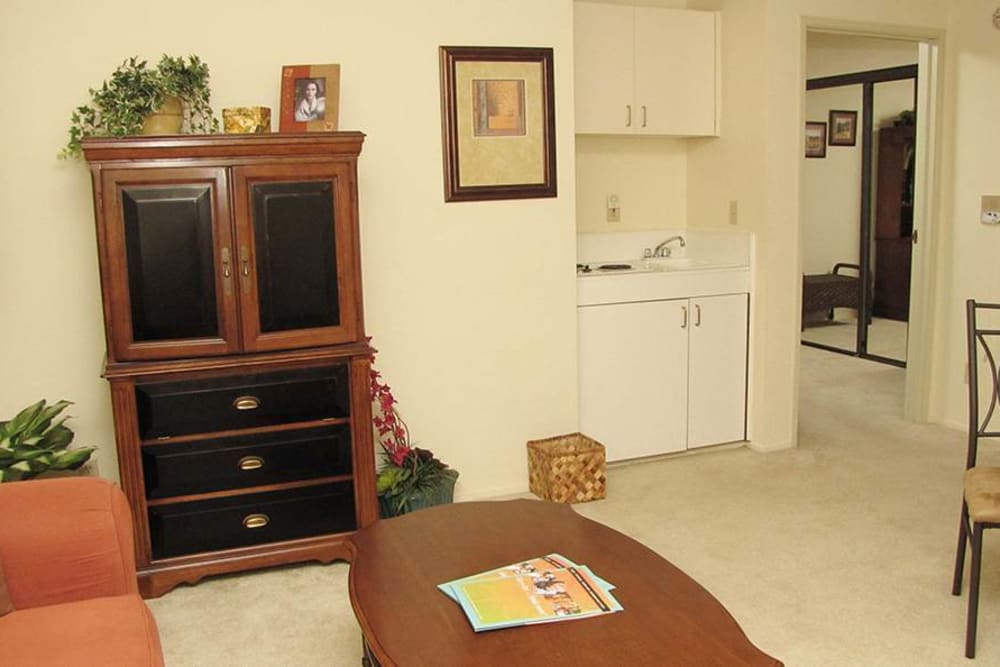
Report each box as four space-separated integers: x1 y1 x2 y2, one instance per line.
439 46 556 202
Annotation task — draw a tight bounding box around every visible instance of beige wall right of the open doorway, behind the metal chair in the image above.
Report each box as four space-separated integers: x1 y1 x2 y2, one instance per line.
931 0 1000 428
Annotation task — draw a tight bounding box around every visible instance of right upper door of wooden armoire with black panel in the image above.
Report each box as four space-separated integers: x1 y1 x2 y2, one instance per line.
233 162 360 352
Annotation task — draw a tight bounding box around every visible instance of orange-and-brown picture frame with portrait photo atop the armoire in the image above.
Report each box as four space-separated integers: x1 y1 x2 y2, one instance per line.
278 65 340 132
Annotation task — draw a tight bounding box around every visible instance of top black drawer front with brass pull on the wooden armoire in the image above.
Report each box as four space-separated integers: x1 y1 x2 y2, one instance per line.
135 365 350 440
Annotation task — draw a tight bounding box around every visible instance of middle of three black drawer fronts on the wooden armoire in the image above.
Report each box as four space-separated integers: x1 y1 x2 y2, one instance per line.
142 424 351 498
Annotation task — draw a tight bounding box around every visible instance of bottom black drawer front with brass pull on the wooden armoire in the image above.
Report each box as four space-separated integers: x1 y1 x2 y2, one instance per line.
149 482 357 559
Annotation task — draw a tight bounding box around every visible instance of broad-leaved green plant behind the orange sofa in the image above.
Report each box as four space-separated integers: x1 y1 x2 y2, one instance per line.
0 399 95 482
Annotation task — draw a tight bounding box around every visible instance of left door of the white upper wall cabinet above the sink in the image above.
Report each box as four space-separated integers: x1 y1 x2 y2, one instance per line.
573 2 637 134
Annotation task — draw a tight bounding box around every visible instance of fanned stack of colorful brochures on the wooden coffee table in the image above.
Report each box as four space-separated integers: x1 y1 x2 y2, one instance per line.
438 554 622 632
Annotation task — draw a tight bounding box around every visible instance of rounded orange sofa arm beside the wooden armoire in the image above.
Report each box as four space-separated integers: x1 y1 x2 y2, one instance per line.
0 477 138 609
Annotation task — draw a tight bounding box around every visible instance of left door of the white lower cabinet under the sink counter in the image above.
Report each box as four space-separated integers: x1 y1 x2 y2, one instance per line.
577 300 688 461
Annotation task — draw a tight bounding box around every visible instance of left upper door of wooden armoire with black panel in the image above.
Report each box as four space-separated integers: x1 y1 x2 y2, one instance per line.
99 168 239 361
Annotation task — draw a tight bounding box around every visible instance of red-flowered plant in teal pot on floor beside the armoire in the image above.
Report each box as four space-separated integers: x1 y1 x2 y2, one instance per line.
370 352 458 518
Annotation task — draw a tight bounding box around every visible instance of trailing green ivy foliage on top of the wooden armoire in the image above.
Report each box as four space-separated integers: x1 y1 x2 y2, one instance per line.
59 54 219 158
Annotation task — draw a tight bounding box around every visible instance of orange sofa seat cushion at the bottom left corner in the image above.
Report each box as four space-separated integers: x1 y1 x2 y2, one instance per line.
0 595 163 667
